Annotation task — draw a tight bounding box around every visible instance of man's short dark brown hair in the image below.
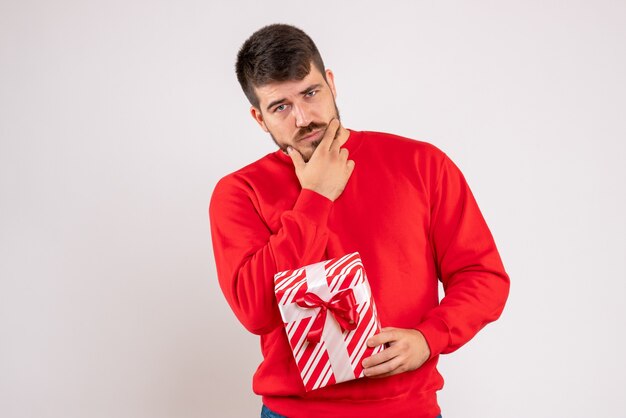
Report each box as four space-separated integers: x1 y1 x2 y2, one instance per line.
235 24 326 108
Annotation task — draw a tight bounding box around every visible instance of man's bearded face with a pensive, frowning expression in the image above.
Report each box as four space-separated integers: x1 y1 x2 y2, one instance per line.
250 64 339 161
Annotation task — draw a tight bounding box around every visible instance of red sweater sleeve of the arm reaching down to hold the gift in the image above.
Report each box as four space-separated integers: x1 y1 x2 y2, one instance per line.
417 157 509 358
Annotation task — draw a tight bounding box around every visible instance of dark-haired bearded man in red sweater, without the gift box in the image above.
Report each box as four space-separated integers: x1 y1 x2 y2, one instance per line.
209 25 509 418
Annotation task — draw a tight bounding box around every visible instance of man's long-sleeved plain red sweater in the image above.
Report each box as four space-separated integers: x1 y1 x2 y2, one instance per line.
209 131 509 418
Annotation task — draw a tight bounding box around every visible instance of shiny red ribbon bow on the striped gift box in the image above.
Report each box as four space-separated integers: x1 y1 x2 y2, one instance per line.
296 289 359 344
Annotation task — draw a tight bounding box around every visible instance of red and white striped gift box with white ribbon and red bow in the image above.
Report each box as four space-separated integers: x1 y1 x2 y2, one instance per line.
274 253 384 392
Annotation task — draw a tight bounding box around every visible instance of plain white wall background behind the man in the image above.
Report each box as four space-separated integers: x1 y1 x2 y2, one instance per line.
0 0 626 418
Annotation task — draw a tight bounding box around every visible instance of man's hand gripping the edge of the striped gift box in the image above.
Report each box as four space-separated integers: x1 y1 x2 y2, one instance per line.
363 327 430 377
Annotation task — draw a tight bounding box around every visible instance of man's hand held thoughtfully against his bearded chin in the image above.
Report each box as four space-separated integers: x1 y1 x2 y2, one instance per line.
288 119 354 201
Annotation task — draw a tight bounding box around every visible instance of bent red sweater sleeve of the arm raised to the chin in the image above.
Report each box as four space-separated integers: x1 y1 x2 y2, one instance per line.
209 176 332 335
